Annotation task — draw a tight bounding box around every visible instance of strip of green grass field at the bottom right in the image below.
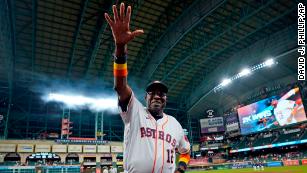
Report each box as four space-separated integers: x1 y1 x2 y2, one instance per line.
187 165 307 173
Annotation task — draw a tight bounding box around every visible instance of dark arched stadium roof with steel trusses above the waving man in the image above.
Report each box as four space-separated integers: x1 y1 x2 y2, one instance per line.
0 0 298 138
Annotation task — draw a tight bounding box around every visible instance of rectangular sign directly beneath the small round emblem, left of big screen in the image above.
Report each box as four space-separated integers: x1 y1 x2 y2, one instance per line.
200 117 225 133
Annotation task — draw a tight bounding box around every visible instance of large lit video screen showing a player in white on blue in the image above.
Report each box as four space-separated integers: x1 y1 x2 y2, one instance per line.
238 88 307 135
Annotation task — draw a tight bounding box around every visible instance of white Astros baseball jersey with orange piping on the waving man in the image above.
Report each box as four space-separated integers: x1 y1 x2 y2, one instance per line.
120 93 190 173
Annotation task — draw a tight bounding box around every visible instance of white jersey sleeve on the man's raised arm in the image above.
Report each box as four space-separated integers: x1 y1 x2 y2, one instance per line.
118 92 143 124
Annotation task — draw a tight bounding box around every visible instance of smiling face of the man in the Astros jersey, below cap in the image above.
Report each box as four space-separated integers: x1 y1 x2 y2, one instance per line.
145 89 166 112
